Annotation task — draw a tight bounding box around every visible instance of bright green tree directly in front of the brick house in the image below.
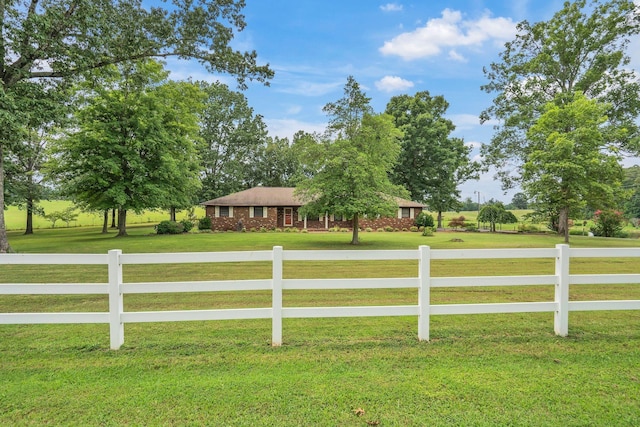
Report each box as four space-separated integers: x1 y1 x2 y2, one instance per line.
296 77 406 245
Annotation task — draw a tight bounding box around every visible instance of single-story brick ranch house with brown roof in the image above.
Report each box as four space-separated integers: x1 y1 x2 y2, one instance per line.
203 187 424 231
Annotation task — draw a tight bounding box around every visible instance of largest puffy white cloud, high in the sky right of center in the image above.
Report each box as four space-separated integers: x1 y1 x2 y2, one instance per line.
379 9 516 60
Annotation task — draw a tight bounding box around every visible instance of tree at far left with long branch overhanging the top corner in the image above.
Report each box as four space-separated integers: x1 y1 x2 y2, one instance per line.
0 0 273 253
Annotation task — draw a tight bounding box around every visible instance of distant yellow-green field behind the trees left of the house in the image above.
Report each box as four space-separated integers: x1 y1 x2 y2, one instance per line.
4 200 204 230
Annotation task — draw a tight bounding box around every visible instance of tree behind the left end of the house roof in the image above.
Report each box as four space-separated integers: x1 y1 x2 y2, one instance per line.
199 82 267 200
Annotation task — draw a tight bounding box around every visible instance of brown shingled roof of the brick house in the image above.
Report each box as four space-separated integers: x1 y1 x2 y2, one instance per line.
203 187 424 208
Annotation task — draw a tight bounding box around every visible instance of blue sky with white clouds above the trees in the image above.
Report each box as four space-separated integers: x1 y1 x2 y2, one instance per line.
167 0 640 202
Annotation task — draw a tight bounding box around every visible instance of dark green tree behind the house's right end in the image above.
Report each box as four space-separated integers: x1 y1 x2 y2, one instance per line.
386 91 479 228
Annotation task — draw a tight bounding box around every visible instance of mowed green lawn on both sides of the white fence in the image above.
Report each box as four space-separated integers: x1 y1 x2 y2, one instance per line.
0 227 640 426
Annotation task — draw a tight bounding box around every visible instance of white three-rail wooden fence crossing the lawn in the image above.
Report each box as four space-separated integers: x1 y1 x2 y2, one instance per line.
0 245 640 349
